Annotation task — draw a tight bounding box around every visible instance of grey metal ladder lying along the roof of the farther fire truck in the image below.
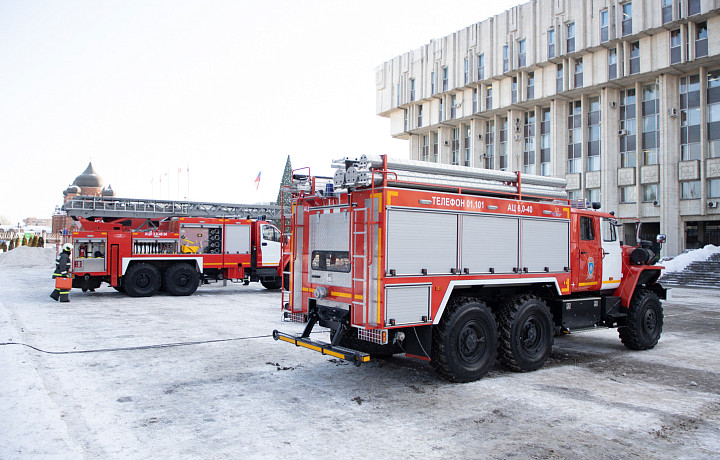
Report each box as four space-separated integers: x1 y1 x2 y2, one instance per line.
62 196 281 219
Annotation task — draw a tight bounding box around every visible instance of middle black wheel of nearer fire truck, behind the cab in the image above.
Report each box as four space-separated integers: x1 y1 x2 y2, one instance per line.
498 295 554 372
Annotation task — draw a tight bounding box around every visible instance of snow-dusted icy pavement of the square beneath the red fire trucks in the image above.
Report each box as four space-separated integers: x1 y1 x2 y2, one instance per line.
0 248 720 459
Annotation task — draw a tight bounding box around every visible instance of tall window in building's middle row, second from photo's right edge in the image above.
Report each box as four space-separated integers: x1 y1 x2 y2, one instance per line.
680 75 701 161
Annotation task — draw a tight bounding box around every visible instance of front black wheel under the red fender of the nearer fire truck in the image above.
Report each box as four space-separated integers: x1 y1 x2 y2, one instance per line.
618 289 663 350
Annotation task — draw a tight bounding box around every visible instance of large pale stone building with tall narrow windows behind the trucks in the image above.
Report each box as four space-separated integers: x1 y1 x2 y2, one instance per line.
376 0 720 256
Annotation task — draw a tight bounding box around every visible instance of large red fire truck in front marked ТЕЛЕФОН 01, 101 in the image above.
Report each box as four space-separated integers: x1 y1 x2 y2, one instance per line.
273 156 668 382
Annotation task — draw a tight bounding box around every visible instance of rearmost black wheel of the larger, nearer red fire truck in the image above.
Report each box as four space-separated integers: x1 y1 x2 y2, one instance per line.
430 298 497 382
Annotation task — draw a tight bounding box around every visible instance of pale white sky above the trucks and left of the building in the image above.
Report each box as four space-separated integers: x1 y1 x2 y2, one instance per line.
0 0 522 222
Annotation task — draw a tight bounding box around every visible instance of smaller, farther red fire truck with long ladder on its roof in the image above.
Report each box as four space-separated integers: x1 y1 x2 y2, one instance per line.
63 196 289 297
